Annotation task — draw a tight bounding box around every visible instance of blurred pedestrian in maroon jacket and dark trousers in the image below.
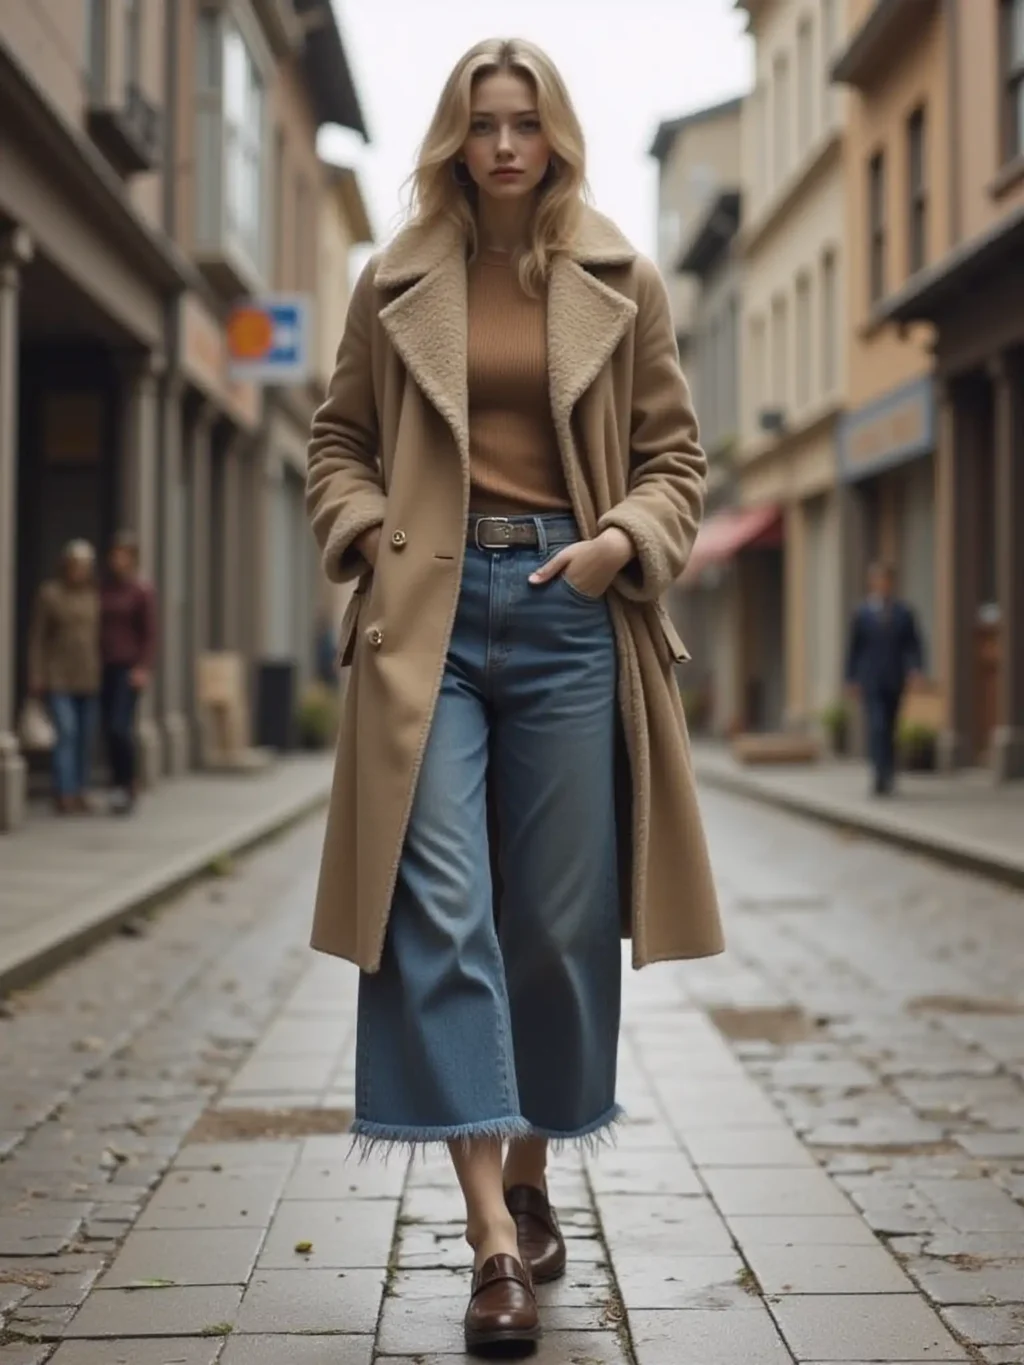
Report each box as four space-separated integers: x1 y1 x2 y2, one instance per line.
100 531 157 815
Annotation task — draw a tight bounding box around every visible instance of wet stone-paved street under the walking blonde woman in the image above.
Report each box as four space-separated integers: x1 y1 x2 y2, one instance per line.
0 792 1024 1365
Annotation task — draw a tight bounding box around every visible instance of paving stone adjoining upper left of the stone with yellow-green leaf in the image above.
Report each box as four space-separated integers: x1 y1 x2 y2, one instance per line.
138 1167 285 1229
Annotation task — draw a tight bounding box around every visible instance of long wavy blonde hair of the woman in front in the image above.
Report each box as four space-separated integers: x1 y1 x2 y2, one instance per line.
411 38 587 295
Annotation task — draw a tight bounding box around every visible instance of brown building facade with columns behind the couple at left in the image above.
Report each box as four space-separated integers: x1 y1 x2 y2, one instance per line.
0 0 365 829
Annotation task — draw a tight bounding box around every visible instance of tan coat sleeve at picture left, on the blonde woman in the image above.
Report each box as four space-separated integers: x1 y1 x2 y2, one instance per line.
306 262 385 583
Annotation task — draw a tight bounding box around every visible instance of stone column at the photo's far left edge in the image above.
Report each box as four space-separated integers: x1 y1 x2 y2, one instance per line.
0 228 33 831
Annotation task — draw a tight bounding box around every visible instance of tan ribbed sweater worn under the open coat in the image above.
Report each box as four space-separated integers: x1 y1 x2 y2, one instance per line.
467 251 572 515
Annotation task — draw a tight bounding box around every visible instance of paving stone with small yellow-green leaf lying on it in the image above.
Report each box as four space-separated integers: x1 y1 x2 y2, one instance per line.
259 1200 399 1269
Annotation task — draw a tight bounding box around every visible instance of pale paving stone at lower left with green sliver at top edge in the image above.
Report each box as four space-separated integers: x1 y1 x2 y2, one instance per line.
66 1284 242 1338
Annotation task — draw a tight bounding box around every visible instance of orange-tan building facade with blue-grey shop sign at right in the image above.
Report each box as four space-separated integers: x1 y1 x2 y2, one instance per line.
833 0 950 748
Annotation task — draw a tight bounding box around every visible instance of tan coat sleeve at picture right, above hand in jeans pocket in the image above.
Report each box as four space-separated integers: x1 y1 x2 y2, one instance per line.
598 261 707 602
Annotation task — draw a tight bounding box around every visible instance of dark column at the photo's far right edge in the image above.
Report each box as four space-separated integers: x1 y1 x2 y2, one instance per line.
990 355 1024 782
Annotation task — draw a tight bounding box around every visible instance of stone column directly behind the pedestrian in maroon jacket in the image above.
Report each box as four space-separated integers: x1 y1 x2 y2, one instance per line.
117 352 162 788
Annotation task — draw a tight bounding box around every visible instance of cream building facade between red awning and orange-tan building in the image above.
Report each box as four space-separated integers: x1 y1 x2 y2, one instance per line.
737 0 847 730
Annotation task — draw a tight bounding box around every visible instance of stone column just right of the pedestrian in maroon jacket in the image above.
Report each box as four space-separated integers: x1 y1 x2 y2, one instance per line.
160 375 188 777
